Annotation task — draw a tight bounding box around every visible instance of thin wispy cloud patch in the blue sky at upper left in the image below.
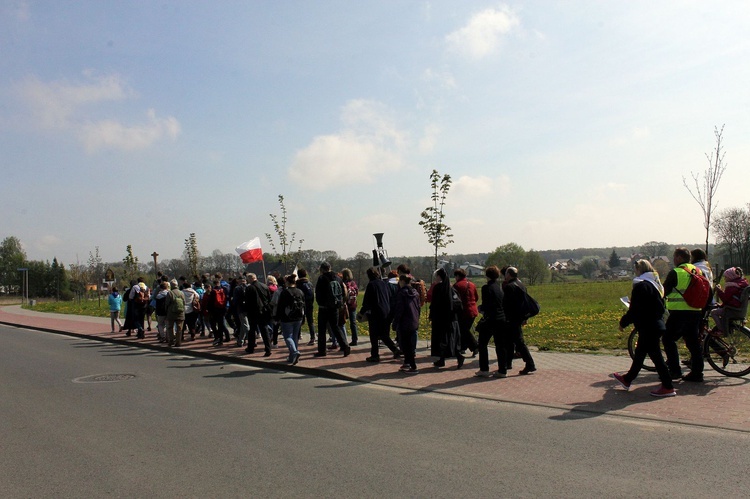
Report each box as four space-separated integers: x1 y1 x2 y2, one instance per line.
19 71 180 152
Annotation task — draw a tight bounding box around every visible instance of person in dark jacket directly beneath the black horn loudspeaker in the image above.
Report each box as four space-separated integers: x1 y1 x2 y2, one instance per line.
359 267 401 362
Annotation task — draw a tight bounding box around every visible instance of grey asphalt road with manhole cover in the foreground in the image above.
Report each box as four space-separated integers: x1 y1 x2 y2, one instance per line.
0 326 750 498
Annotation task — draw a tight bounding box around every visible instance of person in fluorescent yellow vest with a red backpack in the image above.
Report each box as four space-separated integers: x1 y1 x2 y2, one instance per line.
662 248 708 383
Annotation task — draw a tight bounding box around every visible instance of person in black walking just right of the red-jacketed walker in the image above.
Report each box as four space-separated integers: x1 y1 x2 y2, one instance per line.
474 265 508 378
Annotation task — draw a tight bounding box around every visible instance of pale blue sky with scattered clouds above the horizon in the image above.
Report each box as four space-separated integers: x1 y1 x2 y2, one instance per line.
0 0 750 264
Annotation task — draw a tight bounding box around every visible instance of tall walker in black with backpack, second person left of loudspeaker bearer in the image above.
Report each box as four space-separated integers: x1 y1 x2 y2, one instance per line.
315 262 352 357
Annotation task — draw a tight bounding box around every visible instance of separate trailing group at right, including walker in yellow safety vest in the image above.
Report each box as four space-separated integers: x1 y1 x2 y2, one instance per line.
612 248 748 397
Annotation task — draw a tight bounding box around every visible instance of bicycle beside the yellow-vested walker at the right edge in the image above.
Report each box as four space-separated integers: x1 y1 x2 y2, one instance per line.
628 312 750 377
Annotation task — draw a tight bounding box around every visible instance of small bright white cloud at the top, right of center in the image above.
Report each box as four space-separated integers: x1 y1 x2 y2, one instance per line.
445 6 521 59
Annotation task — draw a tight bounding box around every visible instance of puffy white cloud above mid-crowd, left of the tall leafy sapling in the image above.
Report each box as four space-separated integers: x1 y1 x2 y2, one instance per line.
289 100 408 190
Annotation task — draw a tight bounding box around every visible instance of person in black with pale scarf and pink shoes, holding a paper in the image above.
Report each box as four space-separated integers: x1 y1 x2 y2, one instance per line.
612 260 677 397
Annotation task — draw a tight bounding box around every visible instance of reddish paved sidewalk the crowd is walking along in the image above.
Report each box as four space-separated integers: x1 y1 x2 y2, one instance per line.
0 306 750 432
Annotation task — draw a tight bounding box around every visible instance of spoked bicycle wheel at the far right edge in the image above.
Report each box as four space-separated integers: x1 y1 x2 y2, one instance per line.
703 324 750 377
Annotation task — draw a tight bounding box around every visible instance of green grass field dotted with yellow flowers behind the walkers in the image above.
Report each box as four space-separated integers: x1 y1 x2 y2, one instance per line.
19 280 632 353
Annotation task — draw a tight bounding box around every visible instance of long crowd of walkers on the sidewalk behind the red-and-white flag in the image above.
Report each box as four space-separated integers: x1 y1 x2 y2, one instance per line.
109 262 536 378
